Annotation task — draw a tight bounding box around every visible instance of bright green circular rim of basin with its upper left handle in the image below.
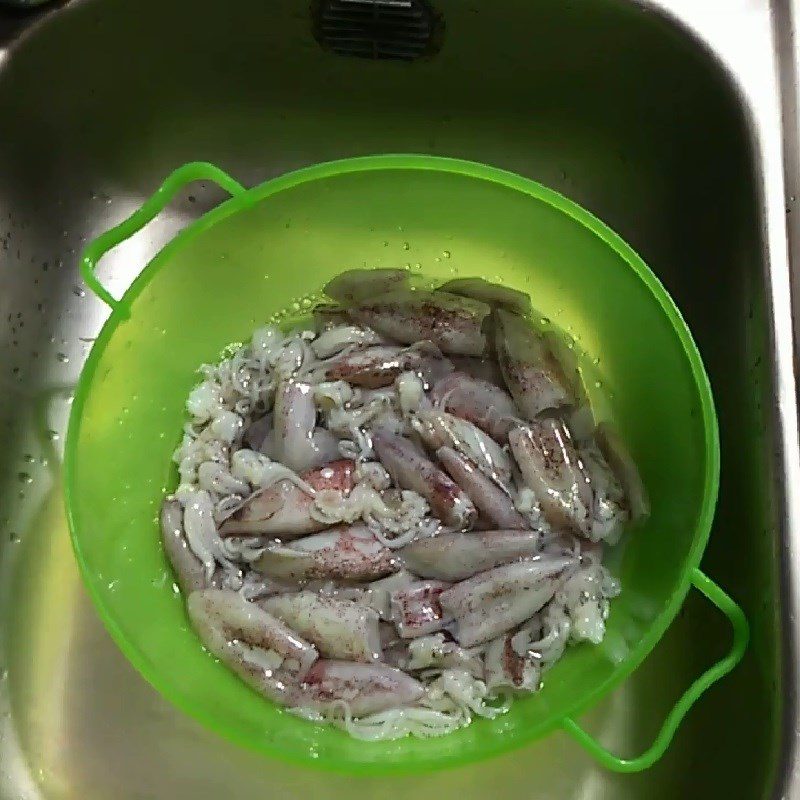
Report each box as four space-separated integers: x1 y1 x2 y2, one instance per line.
65 155 746 774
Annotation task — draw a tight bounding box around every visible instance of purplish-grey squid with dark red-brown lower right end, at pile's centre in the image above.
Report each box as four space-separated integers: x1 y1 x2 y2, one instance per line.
373 431 477 528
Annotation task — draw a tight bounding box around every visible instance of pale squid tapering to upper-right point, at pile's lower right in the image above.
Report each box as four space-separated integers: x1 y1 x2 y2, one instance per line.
439 556 577 647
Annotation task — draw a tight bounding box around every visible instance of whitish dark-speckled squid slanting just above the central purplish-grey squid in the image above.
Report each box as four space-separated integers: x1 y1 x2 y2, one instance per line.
413 409 511 491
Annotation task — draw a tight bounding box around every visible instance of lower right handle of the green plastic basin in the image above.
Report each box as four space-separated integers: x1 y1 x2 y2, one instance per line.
561 568 750 773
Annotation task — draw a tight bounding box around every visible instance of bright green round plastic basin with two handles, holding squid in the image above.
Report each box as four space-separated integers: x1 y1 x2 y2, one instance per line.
66 155 748 773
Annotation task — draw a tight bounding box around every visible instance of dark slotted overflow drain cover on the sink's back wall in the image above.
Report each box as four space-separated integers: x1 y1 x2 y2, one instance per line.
312 0 443 61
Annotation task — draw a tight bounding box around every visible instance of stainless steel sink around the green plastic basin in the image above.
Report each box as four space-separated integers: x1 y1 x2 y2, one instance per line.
0 0 800 800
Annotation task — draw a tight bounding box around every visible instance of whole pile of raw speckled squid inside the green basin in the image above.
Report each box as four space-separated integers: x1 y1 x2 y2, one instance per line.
161 269 648 740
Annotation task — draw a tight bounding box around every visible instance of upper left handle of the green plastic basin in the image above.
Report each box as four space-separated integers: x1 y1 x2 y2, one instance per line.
80 161 247 313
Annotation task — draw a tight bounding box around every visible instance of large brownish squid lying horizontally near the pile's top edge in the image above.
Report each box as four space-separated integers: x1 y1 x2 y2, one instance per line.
348 290 490 356
